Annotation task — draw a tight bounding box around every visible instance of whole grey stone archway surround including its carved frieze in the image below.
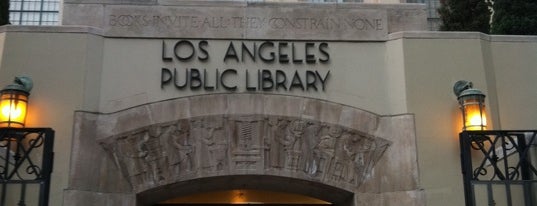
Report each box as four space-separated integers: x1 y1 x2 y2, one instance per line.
66 94 421 205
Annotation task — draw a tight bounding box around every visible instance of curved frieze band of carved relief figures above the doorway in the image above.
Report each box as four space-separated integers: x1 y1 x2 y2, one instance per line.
100 115 390 192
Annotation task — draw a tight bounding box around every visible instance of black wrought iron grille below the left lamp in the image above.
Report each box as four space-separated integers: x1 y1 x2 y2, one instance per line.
0 128 54 206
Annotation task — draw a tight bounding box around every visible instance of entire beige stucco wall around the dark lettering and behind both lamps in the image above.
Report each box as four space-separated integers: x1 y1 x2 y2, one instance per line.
0 27 537 206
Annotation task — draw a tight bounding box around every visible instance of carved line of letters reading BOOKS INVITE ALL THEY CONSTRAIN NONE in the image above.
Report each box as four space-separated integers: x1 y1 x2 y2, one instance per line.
108 14 385 31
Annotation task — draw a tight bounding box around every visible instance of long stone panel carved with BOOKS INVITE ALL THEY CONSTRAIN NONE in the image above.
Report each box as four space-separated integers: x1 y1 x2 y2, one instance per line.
103 5 388 40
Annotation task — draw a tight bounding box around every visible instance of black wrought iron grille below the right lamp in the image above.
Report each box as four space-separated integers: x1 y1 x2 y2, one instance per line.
459 131 537 206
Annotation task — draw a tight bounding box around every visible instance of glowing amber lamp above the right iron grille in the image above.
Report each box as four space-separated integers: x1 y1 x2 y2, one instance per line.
453 80 487 131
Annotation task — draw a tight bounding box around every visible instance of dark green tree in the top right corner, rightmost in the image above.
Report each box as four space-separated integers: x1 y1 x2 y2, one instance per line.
491 0 537 35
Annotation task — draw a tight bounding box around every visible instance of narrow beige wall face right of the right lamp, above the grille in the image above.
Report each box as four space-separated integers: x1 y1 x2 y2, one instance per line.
490 36 537 129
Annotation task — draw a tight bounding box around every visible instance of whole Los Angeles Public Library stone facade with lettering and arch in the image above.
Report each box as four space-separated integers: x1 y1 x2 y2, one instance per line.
0 0 537 206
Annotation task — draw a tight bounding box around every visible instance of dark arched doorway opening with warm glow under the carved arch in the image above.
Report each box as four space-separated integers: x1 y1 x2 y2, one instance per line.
137 175 354 206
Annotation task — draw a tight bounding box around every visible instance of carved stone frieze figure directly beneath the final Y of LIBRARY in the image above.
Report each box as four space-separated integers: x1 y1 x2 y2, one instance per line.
309 125 342 178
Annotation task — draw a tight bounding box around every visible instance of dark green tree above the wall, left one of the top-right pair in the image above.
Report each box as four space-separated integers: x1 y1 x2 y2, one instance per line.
438 0 491 34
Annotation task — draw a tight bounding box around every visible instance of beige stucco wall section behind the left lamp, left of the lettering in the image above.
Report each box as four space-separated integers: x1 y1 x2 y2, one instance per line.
0 27 102 205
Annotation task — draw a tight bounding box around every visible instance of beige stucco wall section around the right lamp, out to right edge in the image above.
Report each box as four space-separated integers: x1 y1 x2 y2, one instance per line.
392 32 537 206
